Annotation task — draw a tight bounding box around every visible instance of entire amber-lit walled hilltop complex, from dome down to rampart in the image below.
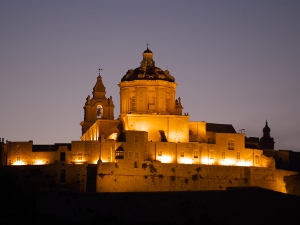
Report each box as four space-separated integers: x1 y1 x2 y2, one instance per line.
2 47 293 192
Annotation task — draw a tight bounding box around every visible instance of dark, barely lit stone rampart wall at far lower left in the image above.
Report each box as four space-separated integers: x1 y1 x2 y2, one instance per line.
0 164 87 192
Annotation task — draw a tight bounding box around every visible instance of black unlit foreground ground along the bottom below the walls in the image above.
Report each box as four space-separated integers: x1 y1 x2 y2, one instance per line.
0 188 300 225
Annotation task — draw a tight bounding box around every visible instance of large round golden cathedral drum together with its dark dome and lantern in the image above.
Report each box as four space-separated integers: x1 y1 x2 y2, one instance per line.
119 47 183 118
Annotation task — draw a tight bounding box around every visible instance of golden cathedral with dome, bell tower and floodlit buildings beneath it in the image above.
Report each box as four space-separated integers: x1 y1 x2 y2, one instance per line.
81 48 272 167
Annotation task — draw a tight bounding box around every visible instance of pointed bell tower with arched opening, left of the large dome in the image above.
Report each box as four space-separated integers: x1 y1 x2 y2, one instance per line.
80 68 115 134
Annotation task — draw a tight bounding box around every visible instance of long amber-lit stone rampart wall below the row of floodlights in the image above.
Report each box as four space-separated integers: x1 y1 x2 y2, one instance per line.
96 162 291 193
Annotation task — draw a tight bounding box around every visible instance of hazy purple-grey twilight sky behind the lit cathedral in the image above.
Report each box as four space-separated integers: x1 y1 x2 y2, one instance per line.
0 0 300 151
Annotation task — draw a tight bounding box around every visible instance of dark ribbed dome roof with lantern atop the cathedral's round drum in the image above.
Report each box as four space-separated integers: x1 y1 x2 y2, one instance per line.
121 48 175 82
